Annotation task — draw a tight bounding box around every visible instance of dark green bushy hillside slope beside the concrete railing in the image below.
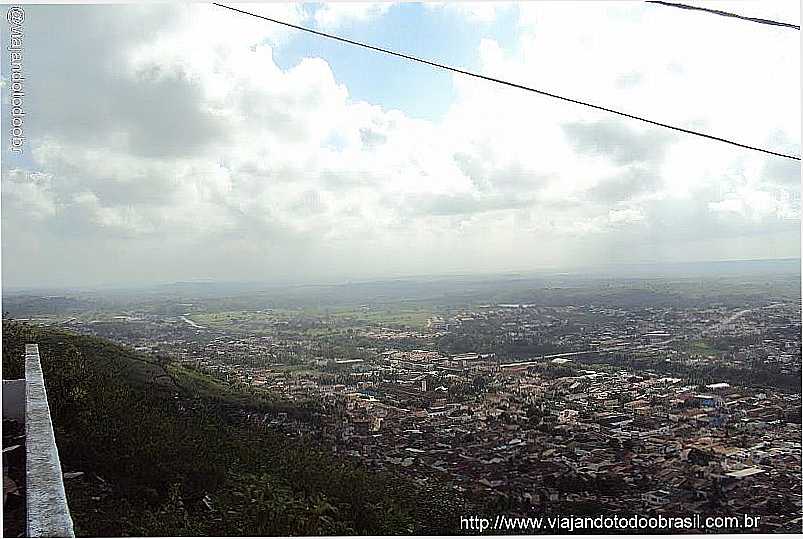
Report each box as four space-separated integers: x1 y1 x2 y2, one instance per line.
3 322 465 536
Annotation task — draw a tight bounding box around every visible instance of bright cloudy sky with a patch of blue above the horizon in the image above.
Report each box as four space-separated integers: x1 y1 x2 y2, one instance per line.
2 0 800 287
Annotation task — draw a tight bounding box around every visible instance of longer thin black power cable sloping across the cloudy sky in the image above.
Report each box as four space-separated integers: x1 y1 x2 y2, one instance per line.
212 2 800 161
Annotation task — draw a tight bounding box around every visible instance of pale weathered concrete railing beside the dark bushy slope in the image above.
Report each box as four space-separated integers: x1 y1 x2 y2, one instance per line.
25 344 75 537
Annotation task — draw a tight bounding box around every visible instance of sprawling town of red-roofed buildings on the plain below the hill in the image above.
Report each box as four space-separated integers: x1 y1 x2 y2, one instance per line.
7 272 801 531
